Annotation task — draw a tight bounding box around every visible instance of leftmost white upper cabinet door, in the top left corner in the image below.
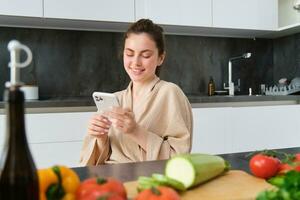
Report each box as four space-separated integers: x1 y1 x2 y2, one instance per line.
0 0 43 17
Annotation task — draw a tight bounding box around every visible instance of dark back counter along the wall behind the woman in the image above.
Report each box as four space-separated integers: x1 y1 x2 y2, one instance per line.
0 95 300 114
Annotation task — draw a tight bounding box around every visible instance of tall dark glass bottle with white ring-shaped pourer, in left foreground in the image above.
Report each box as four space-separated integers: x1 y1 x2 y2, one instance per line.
0 40 39 200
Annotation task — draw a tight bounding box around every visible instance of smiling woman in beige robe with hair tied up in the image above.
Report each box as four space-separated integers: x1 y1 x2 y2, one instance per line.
80 19 193 165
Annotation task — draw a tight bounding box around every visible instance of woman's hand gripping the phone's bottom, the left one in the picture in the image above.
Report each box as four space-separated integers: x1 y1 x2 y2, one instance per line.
88 114 111 138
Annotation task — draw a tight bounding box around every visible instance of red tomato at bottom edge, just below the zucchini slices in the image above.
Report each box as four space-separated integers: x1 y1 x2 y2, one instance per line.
135 186 180 200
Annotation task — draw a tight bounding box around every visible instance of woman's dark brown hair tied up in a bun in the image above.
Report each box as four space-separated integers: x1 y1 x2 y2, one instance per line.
123 19 165 76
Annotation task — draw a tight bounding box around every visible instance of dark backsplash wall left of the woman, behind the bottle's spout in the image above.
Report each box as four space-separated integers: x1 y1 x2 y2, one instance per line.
0 28 128 98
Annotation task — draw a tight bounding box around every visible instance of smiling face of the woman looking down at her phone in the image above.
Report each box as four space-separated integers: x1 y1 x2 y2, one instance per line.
123 33 164 83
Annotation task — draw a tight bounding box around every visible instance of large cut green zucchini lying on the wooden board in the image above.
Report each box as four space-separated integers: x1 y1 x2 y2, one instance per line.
165 154 230 189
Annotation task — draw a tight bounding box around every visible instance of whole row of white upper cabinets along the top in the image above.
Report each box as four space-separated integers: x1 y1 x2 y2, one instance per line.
0 0 299 38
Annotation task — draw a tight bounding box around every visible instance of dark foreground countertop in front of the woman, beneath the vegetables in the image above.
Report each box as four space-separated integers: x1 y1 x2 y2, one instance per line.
74 147 300 182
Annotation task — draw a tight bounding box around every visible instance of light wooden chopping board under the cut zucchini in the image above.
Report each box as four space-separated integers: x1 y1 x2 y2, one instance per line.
125 170 273 200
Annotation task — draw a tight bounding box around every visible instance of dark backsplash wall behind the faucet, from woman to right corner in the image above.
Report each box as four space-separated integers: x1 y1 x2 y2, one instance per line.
161 36 273 94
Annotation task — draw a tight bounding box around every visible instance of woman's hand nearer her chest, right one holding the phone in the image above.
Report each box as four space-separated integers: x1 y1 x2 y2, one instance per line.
106 107 138 134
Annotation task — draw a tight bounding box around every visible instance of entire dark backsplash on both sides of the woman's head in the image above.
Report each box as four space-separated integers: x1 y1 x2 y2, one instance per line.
0 27 300 99
